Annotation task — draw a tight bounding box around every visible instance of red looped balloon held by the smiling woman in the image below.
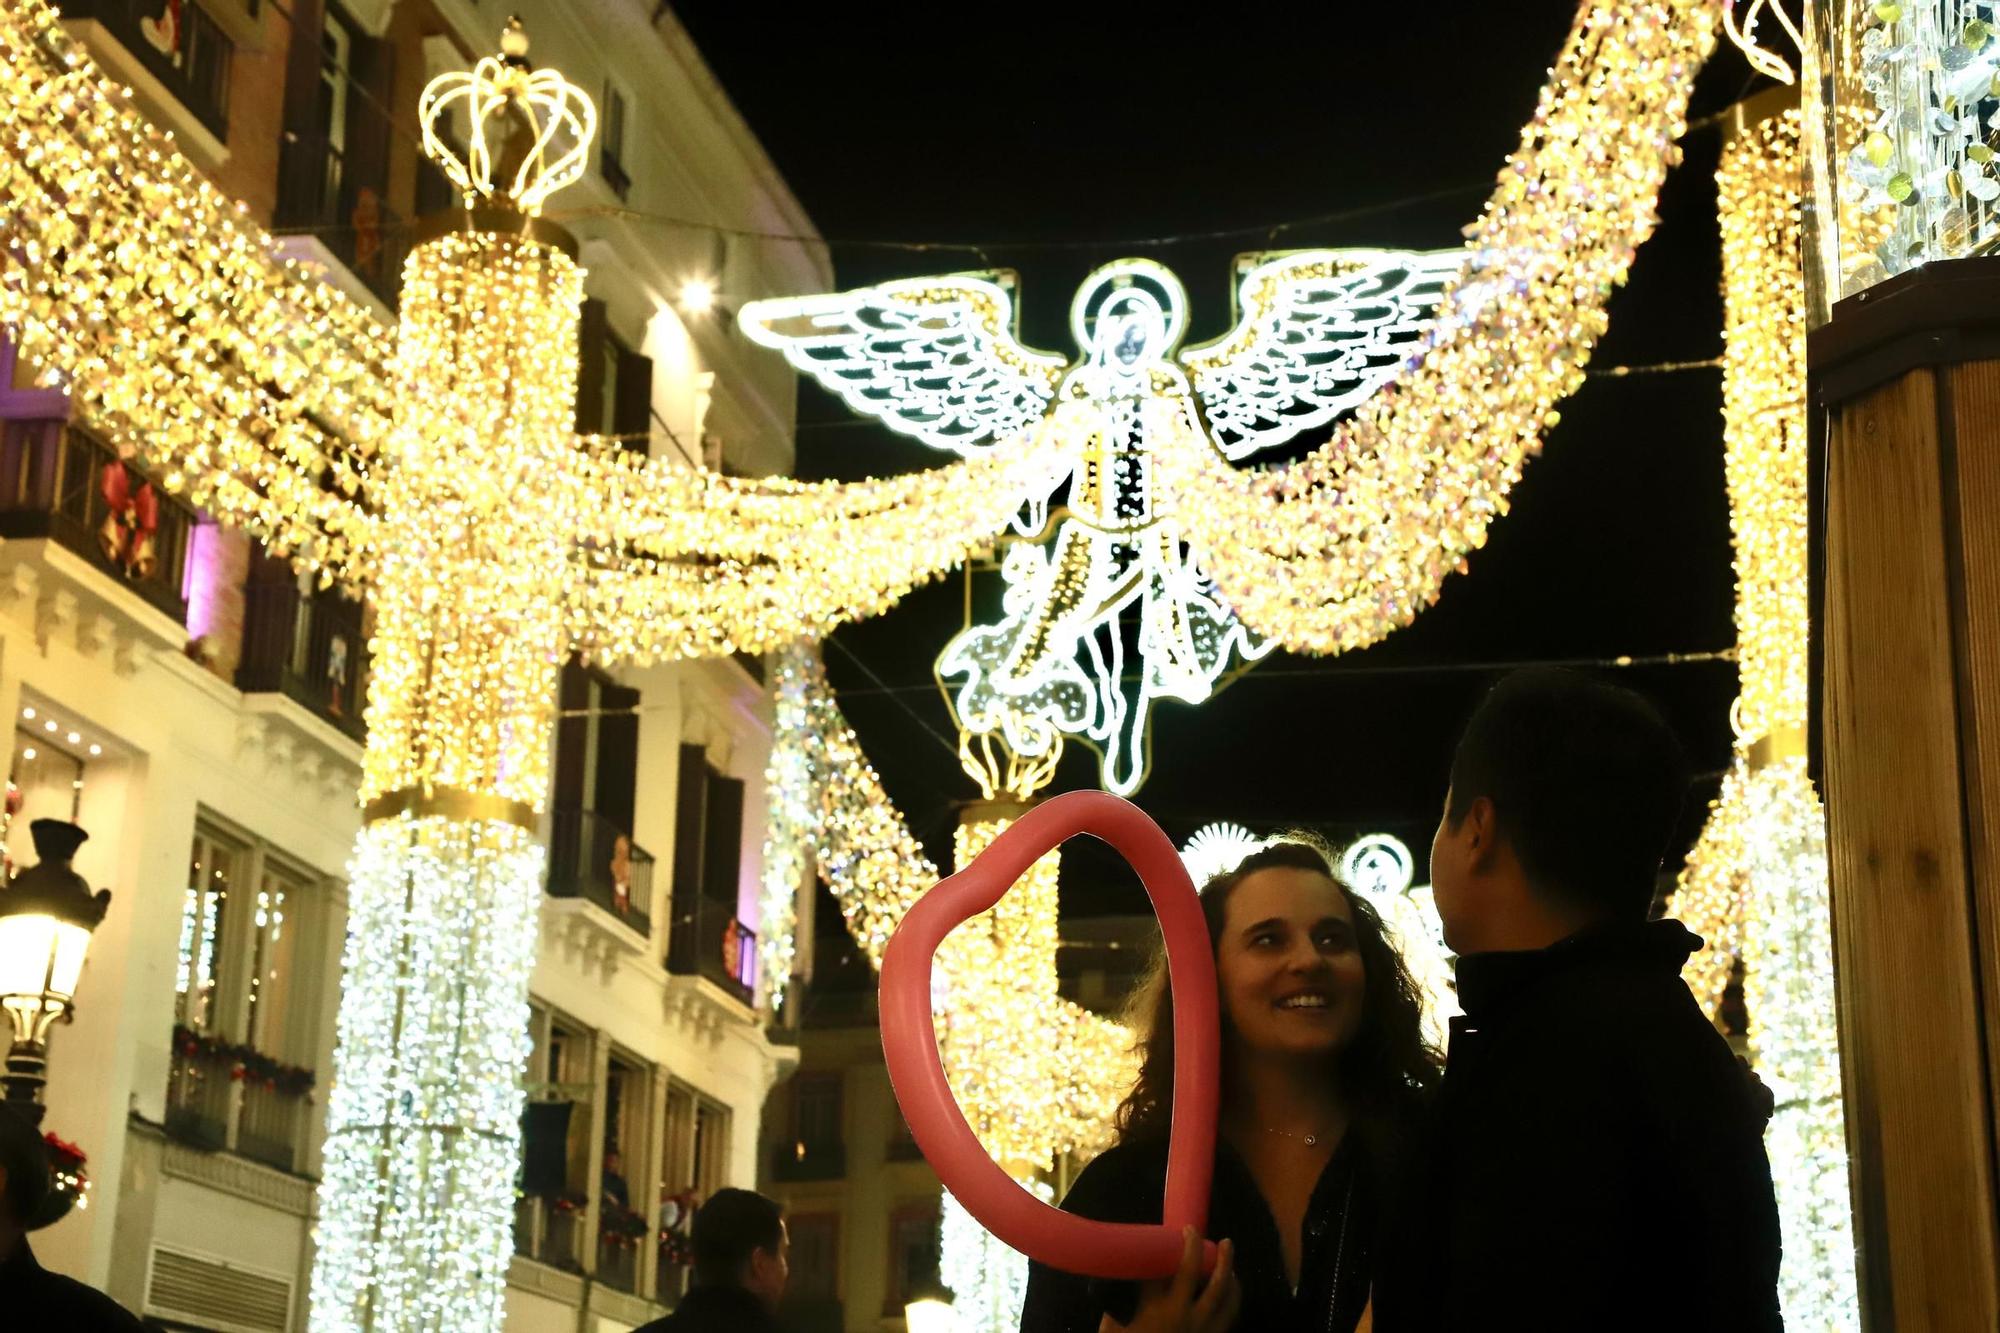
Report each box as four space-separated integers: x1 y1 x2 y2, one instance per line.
882 791 1222 1279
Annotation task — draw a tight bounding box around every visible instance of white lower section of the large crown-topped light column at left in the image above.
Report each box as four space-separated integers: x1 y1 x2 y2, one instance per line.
312 815 544 1333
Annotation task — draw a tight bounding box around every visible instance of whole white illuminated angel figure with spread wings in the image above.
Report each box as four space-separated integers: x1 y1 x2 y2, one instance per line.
740 250 1464 793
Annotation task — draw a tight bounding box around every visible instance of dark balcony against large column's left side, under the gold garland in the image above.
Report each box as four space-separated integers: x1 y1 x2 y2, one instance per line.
236 578 368 741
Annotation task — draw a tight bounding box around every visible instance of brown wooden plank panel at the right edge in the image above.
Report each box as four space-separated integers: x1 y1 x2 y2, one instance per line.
1822 368 2000 1333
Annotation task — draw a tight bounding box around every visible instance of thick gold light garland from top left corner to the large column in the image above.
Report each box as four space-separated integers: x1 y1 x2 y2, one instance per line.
0 0 390 576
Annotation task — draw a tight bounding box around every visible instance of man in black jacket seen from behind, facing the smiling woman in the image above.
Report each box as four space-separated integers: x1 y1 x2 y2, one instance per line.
1376 671 1782 1333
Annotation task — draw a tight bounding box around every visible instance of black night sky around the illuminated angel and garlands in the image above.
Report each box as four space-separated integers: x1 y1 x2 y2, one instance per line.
674 0 1762 915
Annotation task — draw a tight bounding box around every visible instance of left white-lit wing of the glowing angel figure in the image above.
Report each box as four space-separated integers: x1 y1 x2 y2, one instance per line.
736 274 1068 454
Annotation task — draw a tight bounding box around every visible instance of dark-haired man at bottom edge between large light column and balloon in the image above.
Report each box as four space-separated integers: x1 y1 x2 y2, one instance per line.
638 1189 792 1333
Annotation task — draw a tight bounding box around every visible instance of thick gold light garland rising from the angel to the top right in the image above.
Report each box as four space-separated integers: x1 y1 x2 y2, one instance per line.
1162 0 1718 652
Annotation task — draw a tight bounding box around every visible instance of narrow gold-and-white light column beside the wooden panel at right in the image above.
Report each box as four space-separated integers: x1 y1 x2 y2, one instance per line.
1674 112 1860 1331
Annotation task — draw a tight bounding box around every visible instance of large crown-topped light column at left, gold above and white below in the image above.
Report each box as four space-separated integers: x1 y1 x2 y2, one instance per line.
312 23 588 1333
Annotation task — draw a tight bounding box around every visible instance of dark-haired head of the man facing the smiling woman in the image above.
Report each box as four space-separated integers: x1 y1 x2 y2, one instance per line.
1430 669 1688 955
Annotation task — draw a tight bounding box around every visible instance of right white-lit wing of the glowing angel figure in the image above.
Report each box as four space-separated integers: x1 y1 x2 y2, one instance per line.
1180 250 1466 458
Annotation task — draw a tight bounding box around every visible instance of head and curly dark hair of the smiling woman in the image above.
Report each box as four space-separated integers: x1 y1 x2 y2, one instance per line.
1118 839 1438 1141
